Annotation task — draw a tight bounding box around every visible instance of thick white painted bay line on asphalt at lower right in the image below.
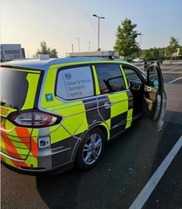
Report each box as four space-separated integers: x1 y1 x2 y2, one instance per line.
129 136 182 209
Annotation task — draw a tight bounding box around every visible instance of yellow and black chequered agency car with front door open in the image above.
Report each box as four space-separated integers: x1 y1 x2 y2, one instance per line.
0 51 167 173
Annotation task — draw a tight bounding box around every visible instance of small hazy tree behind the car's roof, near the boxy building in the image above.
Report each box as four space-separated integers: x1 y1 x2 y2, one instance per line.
35 41 58 58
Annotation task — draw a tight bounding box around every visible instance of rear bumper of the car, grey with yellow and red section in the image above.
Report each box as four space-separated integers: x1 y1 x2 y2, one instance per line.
0 138 79 175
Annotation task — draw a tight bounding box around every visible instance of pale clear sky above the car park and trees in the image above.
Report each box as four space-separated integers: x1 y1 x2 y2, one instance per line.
0 0 182 58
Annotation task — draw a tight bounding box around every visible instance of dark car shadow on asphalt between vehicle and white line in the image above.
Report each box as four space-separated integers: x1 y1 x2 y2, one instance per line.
36 111 182 209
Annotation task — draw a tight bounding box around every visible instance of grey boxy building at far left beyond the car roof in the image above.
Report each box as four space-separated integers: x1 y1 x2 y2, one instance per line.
0 44 25 62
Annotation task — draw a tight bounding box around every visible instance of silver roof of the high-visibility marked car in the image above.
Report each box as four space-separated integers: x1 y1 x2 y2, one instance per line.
0 57 127 70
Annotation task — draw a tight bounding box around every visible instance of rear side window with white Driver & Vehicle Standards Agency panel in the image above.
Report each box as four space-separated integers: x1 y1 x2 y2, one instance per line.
56 66 94 100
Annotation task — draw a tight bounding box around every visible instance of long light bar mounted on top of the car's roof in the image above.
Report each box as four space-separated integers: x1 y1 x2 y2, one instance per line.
67 51 119 58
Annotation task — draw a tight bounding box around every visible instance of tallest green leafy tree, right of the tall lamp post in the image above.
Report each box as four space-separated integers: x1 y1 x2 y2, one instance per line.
114 18 140 59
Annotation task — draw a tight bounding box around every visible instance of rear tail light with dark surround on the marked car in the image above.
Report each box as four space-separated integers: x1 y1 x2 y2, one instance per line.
10 111 61 128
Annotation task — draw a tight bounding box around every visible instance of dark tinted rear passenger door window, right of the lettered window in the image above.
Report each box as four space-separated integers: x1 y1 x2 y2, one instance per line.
95 63 126 94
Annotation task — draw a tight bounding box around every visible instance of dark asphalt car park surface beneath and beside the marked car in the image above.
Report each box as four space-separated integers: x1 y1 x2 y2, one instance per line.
1 64 182 209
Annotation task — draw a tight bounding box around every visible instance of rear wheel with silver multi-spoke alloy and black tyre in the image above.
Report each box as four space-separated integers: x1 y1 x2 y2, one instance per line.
76 128 105 170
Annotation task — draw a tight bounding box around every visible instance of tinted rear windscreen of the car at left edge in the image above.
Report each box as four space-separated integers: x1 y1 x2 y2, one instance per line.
0 68 28 109
